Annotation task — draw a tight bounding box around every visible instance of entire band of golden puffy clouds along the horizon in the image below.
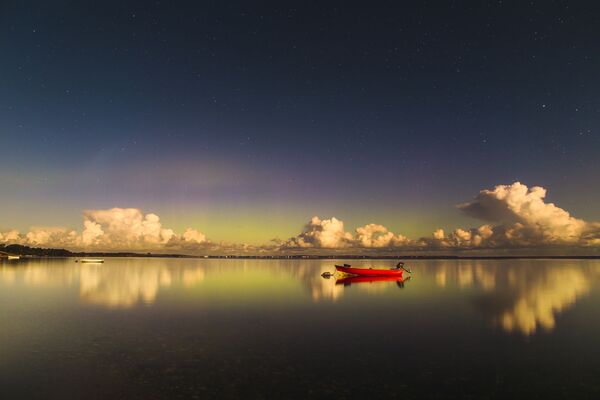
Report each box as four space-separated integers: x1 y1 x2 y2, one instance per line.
0 182 600 254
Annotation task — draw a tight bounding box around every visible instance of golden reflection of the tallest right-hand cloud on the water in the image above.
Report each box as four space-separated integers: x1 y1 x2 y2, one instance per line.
433 262 597 335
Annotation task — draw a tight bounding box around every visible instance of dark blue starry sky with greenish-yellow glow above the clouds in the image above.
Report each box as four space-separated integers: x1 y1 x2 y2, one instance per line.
0 1 600 243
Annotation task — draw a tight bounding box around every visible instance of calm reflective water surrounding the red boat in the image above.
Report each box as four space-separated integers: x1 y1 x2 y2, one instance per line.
0 258 600 399
